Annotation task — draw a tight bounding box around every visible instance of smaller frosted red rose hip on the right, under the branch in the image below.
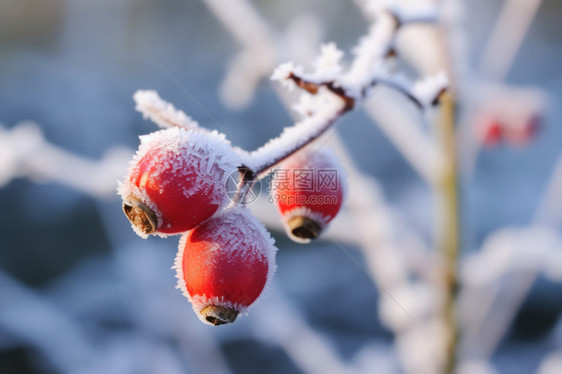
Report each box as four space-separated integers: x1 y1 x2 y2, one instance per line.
270 149 345 243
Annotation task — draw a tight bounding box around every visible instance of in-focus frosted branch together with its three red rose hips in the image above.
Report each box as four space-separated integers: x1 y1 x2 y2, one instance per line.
119 7 447 325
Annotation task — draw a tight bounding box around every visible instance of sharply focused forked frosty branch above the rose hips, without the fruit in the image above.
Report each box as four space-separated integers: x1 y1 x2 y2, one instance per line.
251 13 447 175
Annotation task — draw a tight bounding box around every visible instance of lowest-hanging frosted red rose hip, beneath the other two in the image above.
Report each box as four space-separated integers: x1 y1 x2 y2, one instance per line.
174 206 276 326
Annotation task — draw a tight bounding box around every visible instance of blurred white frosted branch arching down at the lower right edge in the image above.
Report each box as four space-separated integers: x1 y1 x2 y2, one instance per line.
459 227 562 357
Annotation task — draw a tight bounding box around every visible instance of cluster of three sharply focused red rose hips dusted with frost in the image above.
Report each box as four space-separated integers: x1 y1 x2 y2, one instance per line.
119 127 343 326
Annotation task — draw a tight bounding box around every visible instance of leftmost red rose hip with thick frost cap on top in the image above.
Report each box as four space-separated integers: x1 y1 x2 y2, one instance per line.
119 128 240 237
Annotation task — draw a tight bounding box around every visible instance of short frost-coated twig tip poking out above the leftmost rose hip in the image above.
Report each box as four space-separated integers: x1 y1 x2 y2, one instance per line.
133 90 199 130
